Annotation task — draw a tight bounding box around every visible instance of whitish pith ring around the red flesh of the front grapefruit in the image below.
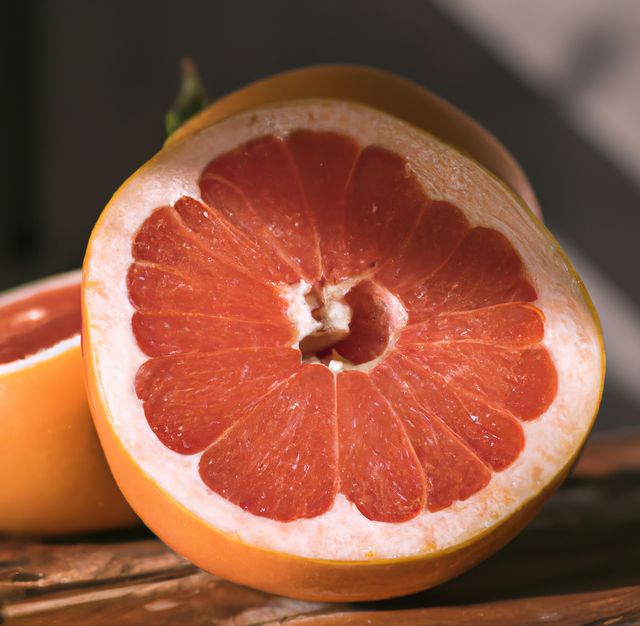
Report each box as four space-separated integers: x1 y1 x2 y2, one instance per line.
85 101 603 560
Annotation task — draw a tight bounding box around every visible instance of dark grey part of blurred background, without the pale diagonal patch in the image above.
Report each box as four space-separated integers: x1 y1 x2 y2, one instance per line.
0 0 640 428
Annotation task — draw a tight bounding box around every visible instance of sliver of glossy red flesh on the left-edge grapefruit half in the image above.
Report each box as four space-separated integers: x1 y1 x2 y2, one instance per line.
0 284 81 363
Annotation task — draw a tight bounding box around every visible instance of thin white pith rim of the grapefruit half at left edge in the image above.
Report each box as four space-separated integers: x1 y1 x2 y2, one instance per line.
0 270 82 377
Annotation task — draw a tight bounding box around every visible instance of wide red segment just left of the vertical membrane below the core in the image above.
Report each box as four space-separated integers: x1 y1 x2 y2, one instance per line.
200 364 338 522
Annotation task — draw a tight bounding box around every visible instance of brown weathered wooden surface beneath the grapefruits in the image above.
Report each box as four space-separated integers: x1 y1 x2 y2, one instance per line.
0 433 640 626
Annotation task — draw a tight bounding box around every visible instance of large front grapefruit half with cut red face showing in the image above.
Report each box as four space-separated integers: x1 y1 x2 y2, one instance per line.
83 69 604 600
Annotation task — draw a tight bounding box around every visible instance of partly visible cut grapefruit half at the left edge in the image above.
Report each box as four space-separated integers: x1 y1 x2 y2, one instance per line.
0 271 137 534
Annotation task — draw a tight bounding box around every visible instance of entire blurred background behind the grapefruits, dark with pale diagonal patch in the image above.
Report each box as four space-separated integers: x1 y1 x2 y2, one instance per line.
0 0 640 429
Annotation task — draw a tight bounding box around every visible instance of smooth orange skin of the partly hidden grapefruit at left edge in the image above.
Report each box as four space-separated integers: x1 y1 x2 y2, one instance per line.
0 272 139 535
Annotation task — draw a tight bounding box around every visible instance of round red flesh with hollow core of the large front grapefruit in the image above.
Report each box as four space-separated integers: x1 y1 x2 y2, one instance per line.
127 129 557 523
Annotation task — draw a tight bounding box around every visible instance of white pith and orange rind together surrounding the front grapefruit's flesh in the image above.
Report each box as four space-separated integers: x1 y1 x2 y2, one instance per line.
83 69 604 600
